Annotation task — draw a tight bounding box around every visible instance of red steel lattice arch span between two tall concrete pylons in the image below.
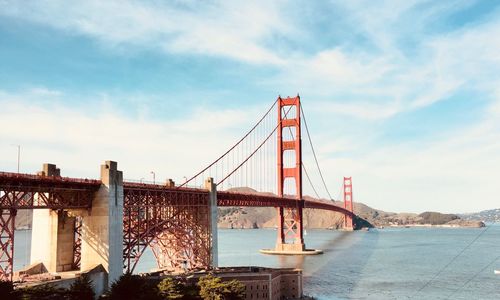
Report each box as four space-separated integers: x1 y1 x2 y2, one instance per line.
123 182 211 271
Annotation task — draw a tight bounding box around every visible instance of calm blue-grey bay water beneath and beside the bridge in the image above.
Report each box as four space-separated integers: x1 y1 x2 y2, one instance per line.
15 225 500 299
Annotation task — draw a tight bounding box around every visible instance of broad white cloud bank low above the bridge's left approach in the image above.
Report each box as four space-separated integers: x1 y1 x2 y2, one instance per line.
0 90 261 181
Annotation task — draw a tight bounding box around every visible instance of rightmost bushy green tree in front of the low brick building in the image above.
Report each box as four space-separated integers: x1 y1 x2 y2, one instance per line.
198 274 245 300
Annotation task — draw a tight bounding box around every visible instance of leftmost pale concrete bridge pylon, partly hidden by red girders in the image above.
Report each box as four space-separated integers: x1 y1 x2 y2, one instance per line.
30 164 75 273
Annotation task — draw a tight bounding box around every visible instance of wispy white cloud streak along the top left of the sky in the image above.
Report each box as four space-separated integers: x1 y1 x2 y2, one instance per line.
0 0 293 64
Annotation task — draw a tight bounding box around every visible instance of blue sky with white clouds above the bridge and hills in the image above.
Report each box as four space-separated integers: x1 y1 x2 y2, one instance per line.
0 0 500 213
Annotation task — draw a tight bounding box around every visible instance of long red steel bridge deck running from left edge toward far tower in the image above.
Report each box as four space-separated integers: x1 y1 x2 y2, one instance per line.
0 172 354 217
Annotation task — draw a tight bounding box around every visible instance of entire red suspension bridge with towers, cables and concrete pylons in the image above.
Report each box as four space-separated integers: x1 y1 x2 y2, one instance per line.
0 95 356 282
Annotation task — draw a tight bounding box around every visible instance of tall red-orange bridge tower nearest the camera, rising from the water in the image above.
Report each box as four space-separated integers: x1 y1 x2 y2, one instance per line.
275 95 305 252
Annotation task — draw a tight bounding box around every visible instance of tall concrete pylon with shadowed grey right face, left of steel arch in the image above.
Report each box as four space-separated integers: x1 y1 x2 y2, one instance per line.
80 161 123 286
